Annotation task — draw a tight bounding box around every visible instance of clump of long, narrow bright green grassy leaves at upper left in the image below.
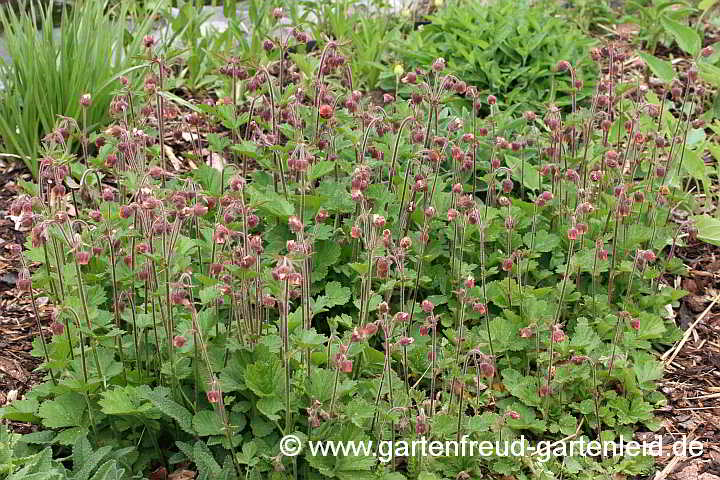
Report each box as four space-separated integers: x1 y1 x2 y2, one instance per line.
0 0 154 176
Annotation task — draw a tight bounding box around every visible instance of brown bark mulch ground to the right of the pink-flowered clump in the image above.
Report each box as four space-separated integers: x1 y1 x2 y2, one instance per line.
649 241 720 480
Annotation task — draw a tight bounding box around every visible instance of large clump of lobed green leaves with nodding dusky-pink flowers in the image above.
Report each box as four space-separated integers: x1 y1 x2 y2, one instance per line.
2 17 716 479
